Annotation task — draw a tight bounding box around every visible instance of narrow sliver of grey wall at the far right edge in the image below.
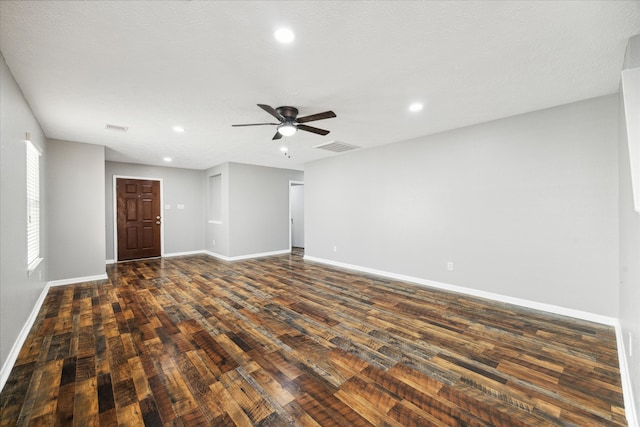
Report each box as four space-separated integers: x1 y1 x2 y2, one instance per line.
619 36 640 425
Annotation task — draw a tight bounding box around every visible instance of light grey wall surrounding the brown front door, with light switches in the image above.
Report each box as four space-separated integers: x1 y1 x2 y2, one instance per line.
102 162 205 263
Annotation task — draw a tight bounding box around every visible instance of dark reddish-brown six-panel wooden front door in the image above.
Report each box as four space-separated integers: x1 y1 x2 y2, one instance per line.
116 178 162 261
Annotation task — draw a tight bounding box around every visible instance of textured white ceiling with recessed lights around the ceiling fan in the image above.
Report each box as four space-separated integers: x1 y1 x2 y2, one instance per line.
0 1 640 169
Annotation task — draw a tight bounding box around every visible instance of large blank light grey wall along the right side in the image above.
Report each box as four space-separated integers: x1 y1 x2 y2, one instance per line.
305 95 618 317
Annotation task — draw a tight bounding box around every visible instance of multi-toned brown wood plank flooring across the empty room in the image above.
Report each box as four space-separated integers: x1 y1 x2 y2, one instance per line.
0 253 626 426
